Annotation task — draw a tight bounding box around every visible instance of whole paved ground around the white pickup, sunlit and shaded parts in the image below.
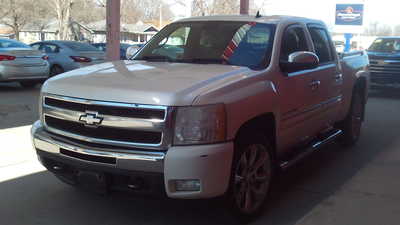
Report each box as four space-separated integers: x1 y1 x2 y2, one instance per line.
0 83 400 225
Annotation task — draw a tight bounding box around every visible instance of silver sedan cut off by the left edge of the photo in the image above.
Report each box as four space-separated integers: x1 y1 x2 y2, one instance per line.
0 38 49 87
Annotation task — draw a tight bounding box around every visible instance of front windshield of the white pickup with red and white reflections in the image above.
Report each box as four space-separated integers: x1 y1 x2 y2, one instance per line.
134 21 275 69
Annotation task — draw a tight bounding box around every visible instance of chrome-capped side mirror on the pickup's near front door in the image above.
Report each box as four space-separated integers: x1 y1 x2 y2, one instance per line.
279 51 319 73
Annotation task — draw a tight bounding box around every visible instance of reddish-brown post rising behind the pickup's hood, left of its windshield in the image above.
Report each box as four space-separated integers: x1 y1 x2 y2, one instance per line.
106 0 121 61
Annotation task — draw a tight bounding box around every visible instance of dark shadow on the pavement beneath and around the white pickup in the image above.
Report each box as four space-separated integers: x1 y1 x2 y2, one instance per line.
0 141 390 225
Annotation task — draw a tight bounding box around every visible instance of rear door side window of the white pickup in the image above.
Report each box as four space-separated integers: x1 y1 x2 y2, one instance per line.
309 27 334 64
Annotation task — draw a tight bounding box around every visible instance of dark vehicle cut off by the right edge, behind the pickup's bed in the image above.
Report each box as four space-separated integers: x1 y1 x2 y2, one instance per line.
367 37 400 86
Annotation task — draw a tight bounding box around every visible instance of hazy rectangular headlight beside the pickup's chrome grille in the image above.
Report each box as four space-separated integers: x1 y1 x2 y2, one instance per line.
174 104 226 145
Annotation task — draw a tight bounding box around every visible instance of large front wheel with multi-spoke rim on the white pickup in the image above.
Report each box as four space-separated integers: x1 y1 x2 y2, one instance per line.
226 135 274 222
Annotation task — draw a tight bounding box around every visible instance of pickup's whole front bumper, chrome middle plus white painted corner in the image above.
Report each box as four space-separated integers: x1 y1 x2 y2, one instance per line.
31 121 233 199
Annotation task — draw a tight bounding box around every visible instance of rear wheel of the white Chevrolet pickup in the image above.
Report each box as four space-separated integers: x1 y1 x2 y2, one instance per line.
341 89 365 146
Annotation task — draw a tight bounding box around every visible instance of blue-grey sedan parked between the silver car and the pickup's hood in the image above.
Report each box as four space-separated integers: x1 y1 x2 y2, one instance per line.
31 41 105 76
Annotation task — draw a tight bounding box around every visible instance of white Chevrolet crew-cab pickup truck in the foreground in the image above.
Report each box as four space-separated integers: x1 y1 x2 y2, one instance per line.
31 16 369 217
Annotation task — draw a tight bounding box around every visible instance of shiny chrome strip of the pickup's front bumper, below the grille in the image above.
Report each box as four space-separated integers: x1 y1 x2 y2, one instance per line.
31 121 165 173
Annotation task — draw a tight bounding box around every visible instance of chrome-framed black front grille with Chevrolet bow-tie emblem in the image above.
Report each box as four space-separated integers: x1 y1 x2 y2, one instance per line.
42 95 172 150
